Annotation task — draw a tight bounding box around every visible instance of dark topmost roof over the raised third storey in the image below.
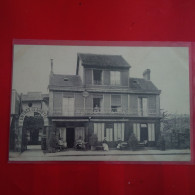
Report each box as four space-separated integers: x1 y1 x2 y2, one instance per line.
78 53 131 68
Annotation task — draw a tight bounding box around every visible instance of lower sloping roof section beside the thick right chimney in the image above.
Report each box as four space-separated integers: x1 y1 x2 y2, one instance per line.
129 78 159 91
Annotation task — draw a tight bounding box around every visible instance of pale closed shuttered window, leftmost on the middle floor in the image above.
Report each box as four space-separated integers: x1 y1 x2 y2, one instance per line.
62 97 74 116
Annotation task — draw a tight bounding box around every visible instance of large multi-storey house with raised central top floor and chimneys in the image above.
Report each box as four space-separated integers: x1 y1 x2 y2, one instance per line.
48 54 160 148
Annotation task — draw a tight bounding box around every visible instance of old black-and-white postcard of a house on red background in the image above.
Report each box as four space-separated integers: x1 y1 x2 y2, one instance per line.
9 43 191 162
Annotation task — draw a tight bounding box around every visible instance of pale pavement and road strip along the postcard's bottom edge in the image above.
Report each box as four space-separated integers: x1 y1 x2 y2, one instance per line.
9 145 191 162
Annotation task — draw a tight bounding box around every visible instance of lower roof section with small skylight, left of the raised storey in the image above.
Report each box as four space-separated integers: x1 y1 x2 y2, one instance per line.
49 74 82 87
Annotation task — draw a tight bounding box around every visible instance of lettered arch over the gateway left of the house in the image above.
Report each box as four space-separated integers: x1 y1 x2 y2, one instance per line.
16 107 49 152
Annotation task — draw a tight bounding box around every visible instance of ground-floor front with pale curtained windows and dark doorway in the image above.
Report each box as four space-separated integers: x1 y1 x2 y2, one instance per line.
52 119 160 148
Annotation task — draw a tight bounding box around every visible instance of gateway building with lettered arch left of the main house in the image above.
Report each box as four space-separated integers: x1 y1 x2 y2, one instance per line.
9 89 49 152
